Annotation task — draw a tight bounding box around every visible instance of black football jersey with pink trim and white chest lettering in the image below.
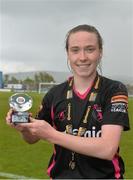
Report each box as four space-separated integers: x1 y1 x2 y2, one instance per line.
38 76 129 179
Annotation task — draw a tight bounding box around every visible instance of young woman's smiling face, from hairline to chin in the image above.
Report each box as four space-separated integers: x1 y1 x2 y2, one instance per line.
67 31 102 78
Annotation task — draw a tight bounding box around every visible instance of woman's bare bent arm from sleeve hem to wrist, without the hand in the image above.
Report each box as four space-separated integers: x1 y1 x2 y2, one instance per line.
49 125 123 160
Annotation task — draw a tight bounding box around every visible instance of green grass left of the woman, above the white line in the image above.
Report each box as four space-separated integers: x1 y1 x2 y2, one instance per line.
0 92 52 179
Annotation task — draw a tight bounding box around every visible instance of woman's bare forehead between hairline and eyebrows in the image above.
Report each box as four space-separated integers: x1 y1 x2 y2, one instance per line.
68 31 98 46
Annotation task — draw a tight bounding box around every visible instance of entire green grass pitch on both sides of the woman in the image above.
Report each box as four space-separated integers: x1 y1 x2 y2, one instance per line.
0 92 133 179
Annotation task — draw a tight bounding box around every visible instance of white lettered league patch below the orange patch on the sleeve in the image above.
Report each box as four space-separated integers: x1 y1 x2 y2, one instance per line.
111 103 127 113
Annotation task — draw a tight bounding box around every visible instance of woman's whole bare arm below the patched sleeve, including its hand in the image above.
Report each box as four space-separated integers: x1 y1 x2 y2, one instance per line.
17 119 123 160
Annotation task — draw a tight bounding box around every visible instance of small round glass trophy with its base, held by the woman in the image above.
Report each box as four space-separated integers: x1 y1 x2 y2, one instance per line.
9 93 33 124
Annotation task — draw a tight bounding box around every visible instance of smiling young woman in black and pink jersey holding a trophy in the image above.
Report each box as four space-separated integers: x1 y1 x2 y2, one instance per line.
6 25 129 179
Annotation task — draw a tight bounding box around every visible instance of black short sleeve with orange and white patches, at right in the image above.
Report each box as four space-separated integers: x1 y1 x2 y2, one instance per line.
102 81 130 130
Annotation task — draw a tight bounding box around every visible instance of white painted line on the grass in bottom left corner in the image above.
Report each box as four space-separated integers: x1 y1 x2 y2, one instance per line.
0 172 36 179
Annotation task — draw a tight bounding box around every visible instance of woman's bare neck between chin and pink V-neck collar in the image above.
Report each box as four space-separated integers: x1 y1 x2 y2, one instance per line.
74 73 96 94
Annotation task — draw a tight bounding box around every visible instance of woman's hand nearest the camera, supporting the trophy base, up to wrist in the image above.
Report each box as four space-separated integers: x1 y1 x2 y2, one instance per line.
15 117 56 141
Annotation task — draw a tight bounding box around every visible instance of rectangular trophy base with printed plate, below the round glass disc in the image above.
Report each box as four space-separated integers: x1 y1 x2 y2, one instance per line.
12 112 29 124
